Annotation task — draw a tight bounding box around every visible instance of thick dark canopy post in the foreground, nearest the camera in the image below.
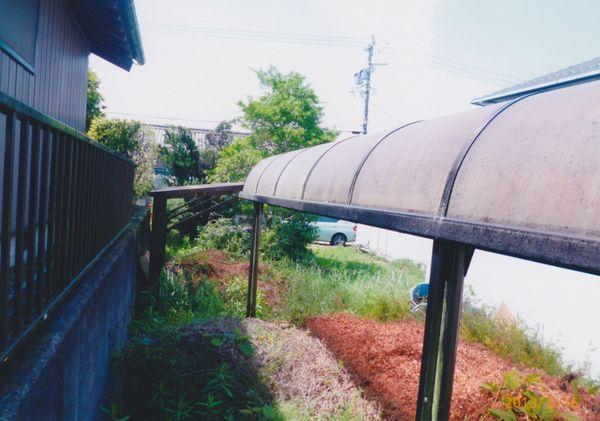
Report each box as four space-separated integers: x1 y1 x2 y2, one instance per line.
416 240 473 420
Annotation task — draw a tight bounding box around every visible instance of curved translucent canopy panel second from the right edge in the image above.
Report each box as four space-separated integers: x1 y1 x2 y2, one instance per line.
351 105 500 215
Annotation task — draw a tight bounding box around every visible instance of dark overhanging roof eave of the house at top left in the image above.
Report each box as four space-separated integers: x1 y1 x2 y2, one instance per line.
69 0 145 70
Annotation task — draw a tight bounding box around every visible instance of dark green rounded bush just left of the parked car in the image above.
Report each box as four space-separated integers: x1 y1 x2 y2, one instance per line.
261 213 317 260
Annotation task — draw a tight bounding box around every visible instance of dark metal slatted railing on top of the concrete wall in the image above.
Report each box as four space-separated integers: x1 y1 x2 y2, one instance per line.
0 93 134 361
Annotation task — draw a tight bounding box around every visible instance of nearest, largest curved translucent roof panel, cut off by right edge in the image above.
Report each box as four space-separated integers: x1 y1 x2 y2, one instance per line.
448 83 600 236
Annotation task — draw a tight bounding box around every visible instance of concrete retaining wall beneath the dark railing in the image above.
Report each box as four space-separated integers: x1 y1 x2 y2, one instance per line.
0 211 145 420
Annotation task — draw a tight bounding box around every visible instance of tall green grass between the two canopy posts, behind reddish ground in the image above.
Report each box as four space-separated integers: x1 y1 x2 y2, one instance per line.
276 247 425 324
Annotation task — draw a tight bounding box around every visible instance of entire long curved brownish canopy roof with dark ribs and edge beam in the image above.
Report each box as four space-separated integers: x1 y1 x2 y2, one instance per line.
240 82 600 274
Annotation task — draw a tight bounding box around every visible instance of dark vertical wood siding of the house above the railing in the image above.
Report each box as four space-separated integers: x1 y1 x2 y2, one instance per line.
0 0 89 131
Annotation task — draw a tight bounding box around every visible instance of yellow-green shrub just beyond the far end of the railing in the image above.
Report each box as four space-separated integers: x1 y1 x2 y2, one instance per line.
88 117 158 197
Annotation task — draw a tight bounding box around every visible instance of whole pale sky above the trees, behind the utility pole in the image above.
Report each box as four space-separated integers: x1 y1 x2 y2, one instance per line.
91 0 600 130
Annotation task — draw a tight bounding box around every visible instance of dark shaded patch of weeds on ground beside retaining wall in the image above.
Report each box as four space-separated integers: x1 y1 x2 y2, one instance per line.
113 318 280 420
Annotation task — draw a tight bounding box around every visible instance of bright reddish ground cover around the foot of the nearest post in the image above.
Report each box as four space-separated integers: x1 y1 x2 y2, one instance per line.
308 314 600 420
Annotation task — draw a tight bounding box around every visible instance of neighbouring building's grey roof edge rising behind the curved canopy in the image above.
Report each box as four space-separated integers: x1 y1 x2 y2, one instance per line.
471 57 600 105
